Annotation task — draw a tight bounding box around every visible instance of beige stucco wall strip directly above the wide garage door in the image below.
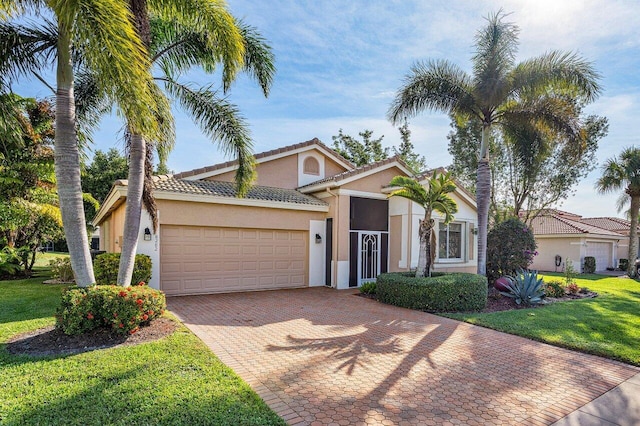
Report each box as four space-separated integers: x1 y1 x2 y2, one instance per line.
157 200 326 231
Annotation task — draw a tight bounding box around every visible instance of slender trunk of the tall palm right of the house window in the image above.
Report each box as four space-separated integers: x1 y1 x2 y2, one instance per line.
476 125 491 275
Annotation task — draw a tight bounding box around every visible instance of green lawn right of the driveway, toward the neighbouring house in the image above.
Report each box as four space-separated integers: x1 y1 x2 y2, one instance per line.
446 274 640 365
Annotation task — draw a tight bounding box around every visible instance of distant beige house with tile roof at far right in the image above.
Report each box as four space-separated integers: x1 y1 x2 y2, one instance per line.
530 209 630 271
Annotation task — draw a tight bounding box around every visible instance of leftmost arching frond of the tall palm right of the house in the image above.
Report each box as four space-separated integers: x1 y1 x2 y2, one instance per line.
387 61 479 124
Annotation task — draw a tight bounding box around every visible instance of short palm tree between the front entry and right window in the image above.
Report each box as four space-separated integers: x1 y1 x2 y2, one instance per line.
389 170 458 277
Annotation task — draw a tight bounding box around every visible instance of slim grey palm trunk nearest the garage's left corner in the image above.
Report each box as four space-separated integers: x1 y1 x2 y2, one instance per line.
118 133 146 287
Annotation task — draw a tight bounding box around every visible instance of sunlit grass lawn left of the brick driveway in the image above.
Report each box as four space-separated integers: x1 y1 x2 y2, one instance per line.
0 269 285 425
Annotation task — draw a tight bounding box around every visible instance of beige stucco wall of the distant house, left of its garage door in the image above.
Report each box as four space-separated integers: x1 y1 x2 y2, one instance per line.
530 236 582 271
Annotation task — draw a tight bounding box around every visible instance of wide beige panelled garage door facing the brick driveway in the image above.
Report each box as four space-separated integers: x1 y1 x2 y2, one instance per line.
160 225 307 295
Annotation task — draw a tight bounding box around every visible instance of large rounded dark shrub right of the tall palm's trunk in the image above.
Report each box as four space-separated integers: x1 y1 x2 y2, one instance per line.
487 218 538 282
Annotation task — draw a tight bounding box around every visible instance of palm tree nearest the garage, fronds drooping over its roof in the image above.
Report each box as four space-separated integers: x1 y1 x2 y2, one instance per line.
118 0 274 286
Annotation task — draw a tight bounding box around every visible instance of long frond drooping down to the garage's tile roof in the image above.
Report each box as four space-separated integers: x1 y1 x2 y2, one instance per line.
164 79 255 196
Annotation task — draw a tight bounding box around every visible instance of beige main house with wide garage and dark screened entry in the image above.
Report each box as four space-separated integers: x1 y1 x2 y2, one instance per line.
94 139 477 295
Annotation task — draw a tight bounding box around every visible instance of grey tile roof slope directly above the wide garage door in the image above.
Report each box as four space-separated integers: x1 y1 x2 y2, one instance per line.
153 175 327 206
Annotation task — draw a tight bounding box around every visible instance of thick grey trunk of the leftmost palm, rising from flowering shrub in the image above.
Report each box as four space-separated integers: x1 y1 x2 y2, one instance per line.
55 21 96 287
